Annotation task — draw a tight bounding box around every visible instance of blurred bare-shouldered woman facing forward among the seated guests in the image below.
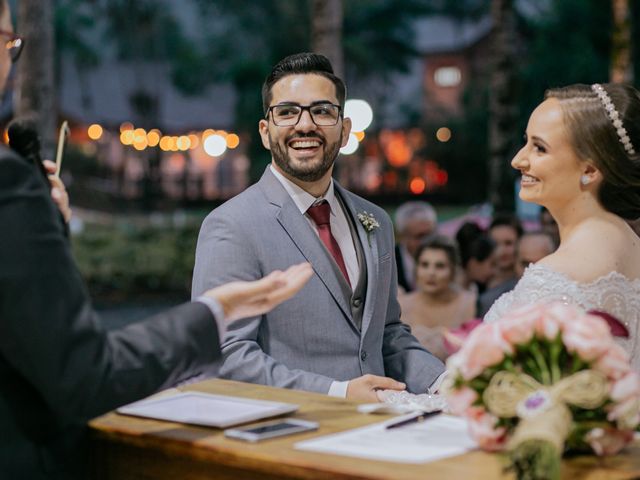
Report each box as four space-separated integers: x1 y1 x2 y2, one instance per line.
400 235 476 360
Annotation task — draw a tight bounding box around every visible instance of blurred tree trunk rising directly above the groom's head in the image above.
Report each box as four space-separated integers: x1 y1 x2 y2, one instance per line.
311 0 344 78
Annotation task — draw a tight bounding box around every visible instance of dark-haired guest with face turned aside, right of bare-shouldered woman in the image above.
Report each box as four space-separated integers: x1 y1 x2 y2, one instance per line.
456 222 496 295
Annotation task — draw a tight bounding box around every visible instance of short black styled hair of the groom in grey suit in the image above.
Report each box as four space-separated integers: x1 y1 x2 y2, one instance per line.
262 52 347 116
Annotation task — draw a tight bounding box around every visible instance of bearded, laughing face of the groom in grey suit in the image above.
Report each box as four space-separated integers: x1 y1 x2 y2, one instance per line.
259 74 351 182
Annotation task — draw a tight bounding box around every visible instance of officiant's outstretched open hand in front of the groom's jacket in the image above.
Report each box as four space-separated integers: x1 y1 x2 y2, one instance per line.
205 263 313 324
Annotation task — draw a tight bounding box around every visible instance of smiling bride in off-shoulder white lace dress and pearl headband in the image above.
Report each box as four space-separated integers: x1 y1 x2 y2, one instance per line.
485 84 640 371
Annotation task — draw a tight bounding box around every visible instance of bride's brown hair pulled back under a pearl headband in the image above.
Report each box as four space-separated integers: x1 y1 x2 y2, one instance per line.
545 83 640 219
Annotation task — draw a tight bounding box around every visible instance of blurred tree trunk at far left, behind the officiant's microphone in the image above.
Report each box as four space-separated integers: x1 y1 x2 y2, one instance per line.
14 0 57 159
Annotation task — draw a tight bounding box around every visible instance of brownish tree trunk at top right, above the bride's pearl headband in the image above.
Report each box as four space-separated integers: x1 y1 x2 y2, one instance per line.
610 0 633 83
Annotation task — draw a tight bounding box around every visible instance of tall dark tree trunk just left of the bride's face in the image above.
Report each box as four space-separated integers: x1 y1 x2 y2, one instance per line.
489 0 516 211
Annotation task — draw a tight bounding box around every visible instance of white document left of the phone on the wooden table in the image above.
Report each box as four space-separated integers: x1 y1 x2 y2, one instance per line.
116 392 298 428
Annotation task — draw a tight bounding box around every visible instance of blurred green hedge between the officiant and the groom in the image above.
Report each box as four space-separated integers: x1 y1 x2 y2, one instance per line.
73 226 198 300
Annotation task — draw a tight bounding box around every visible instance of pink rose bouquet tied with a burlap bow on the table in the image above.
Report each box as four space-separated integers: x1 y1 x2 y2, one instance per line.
445 303 640 479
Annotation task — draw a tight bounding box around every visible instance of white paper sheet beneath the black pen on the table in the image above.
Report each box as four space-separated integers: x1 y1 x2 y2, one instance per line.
295 415 476 463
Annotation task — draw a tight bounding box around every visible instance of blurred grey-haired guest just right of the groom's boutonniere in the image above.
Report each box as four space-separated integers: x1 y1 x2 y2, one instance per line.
395 201 438 292
